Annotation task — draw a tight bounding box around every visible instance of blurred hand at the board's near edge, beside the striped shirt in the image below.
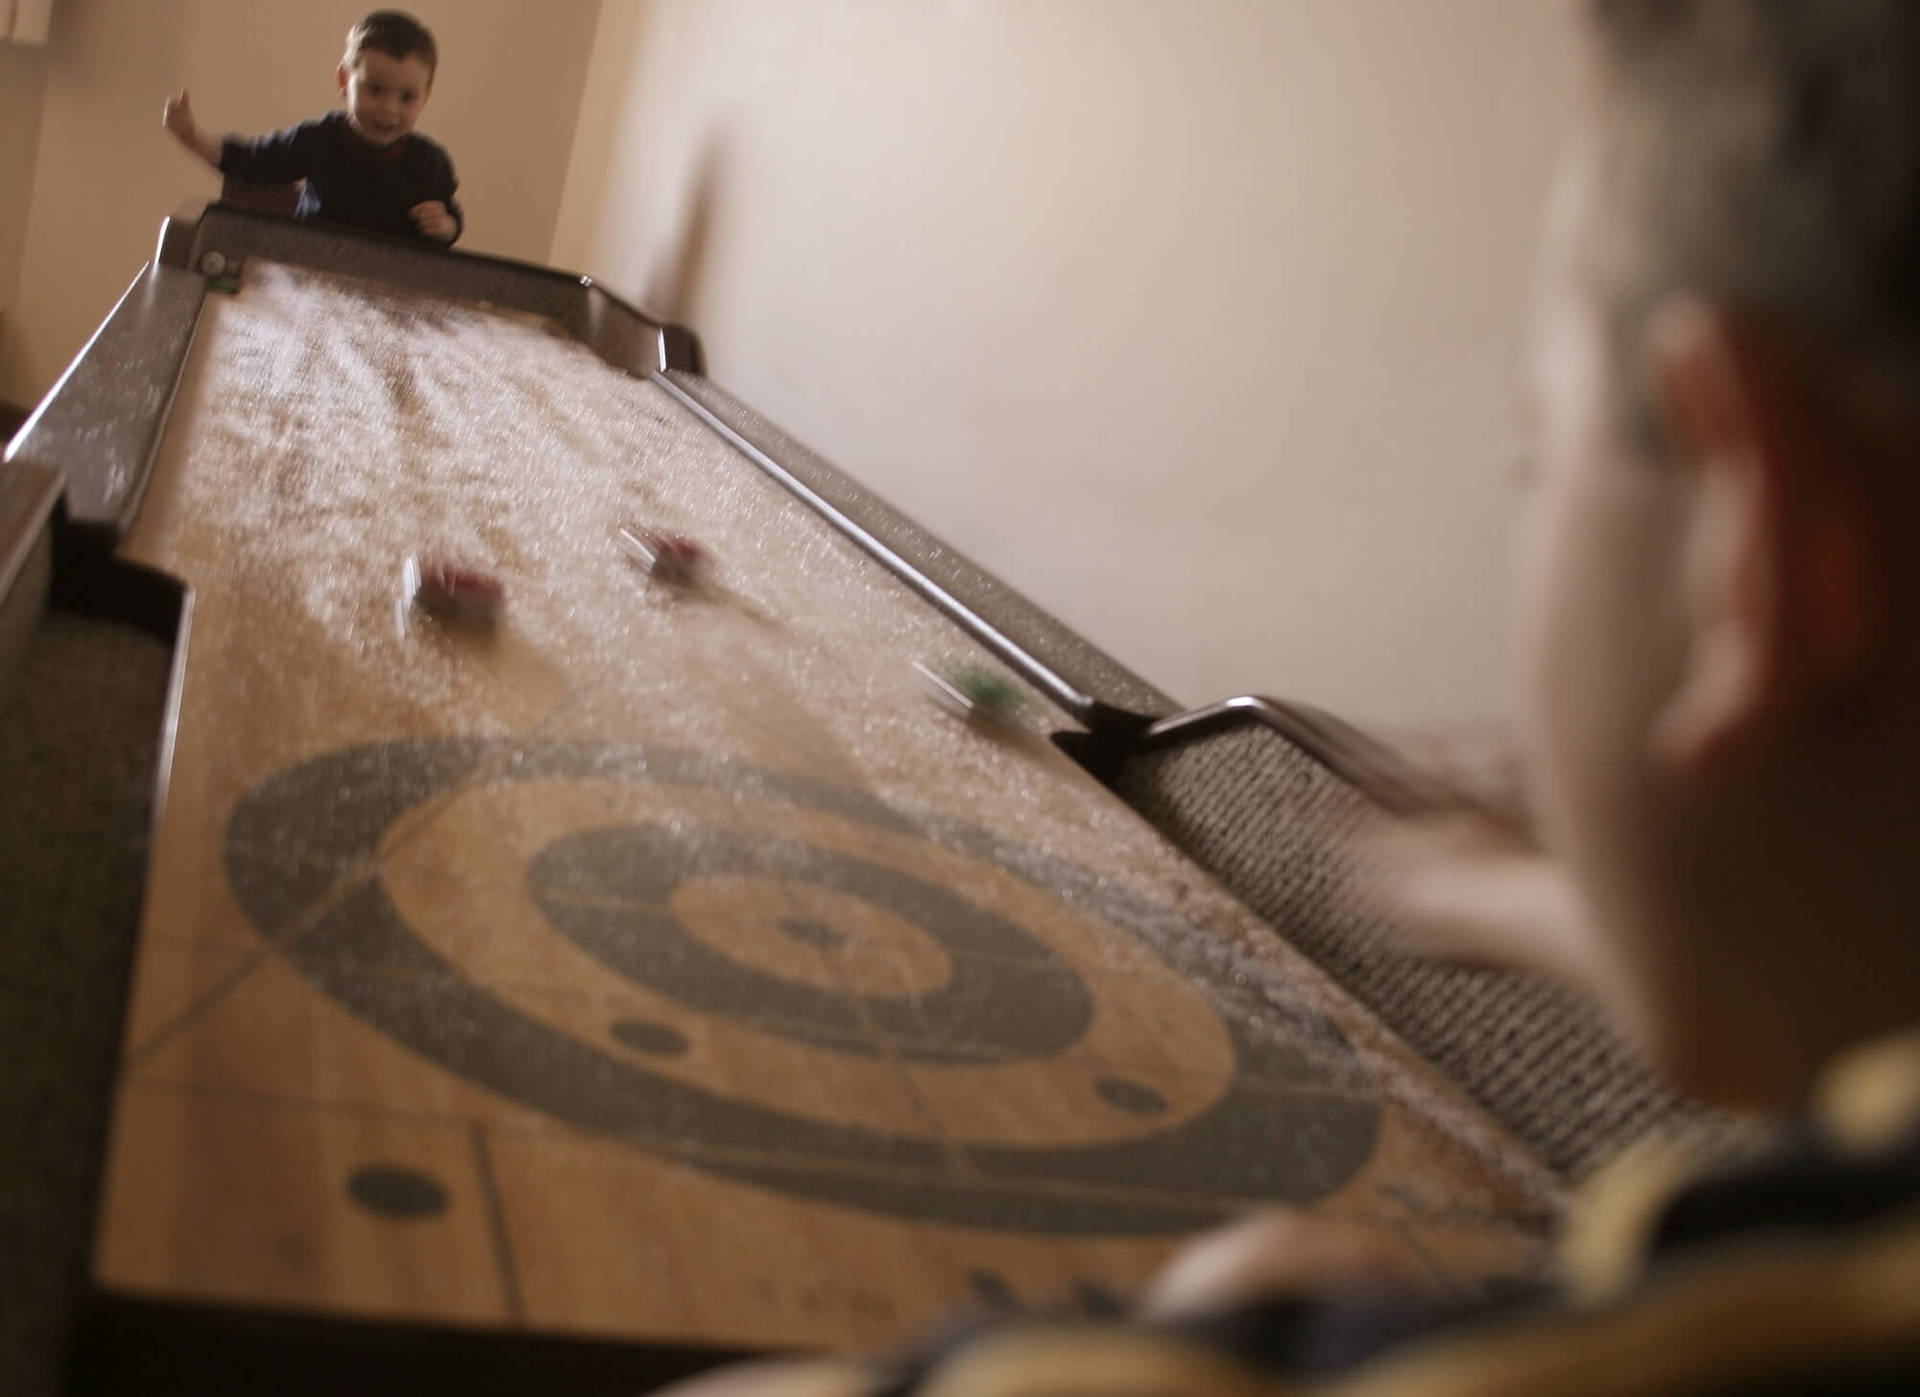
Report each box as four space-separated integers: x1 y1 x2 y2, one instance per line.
1140 1207 1438 1320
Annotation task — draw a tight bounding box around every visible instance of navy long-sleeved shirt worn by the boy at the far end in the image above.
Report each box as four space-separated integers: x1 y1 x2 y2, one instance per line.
221 111 467 247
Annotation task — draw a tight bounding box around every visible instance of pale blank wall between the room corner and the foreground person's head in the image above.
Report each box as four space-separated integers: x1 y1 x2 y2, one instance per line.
555 0 1576 723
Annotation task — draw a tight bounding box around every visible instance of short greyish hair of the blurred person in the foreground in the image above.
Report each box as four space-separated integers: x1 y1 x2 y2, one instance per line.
1584 0 1920 431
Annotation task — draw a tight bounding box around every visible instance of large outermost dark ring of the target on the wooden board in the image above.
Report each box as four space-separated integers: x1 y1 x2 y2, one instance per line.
227 739 1379 1236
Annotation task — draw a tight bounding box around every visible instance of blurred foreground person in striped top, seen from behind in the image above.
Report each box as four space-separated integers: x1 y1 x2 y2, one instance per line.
660 0 1920 1397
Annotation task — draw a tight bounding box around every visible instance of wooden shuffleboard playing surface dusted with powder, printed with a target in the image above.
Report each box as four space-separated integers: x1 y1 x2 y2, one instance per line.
96 265 1549 1347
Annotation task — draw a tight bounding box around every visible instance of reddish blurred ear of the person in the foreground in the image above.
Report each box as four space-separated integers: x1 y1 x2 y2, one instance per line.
1647 299 1882 773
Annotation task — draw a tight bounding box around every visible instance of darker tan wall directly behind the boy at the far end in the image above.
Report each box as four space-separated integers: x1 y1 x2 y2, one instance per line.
0 0 599 401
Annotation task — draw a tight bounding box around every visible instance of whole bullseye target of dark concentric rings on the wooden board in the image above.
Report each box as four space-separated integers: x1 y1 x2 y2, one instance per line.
225 739 1379 1236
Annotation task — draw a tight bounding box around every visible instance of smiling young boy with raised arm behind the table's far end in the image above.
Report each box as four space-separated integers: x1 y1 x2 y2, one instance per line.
163 10 465 244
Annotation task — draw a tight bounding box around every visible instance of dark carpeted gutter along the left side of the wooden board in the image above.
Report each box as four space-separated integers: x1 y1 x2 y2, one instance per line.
0 612 169 1397
